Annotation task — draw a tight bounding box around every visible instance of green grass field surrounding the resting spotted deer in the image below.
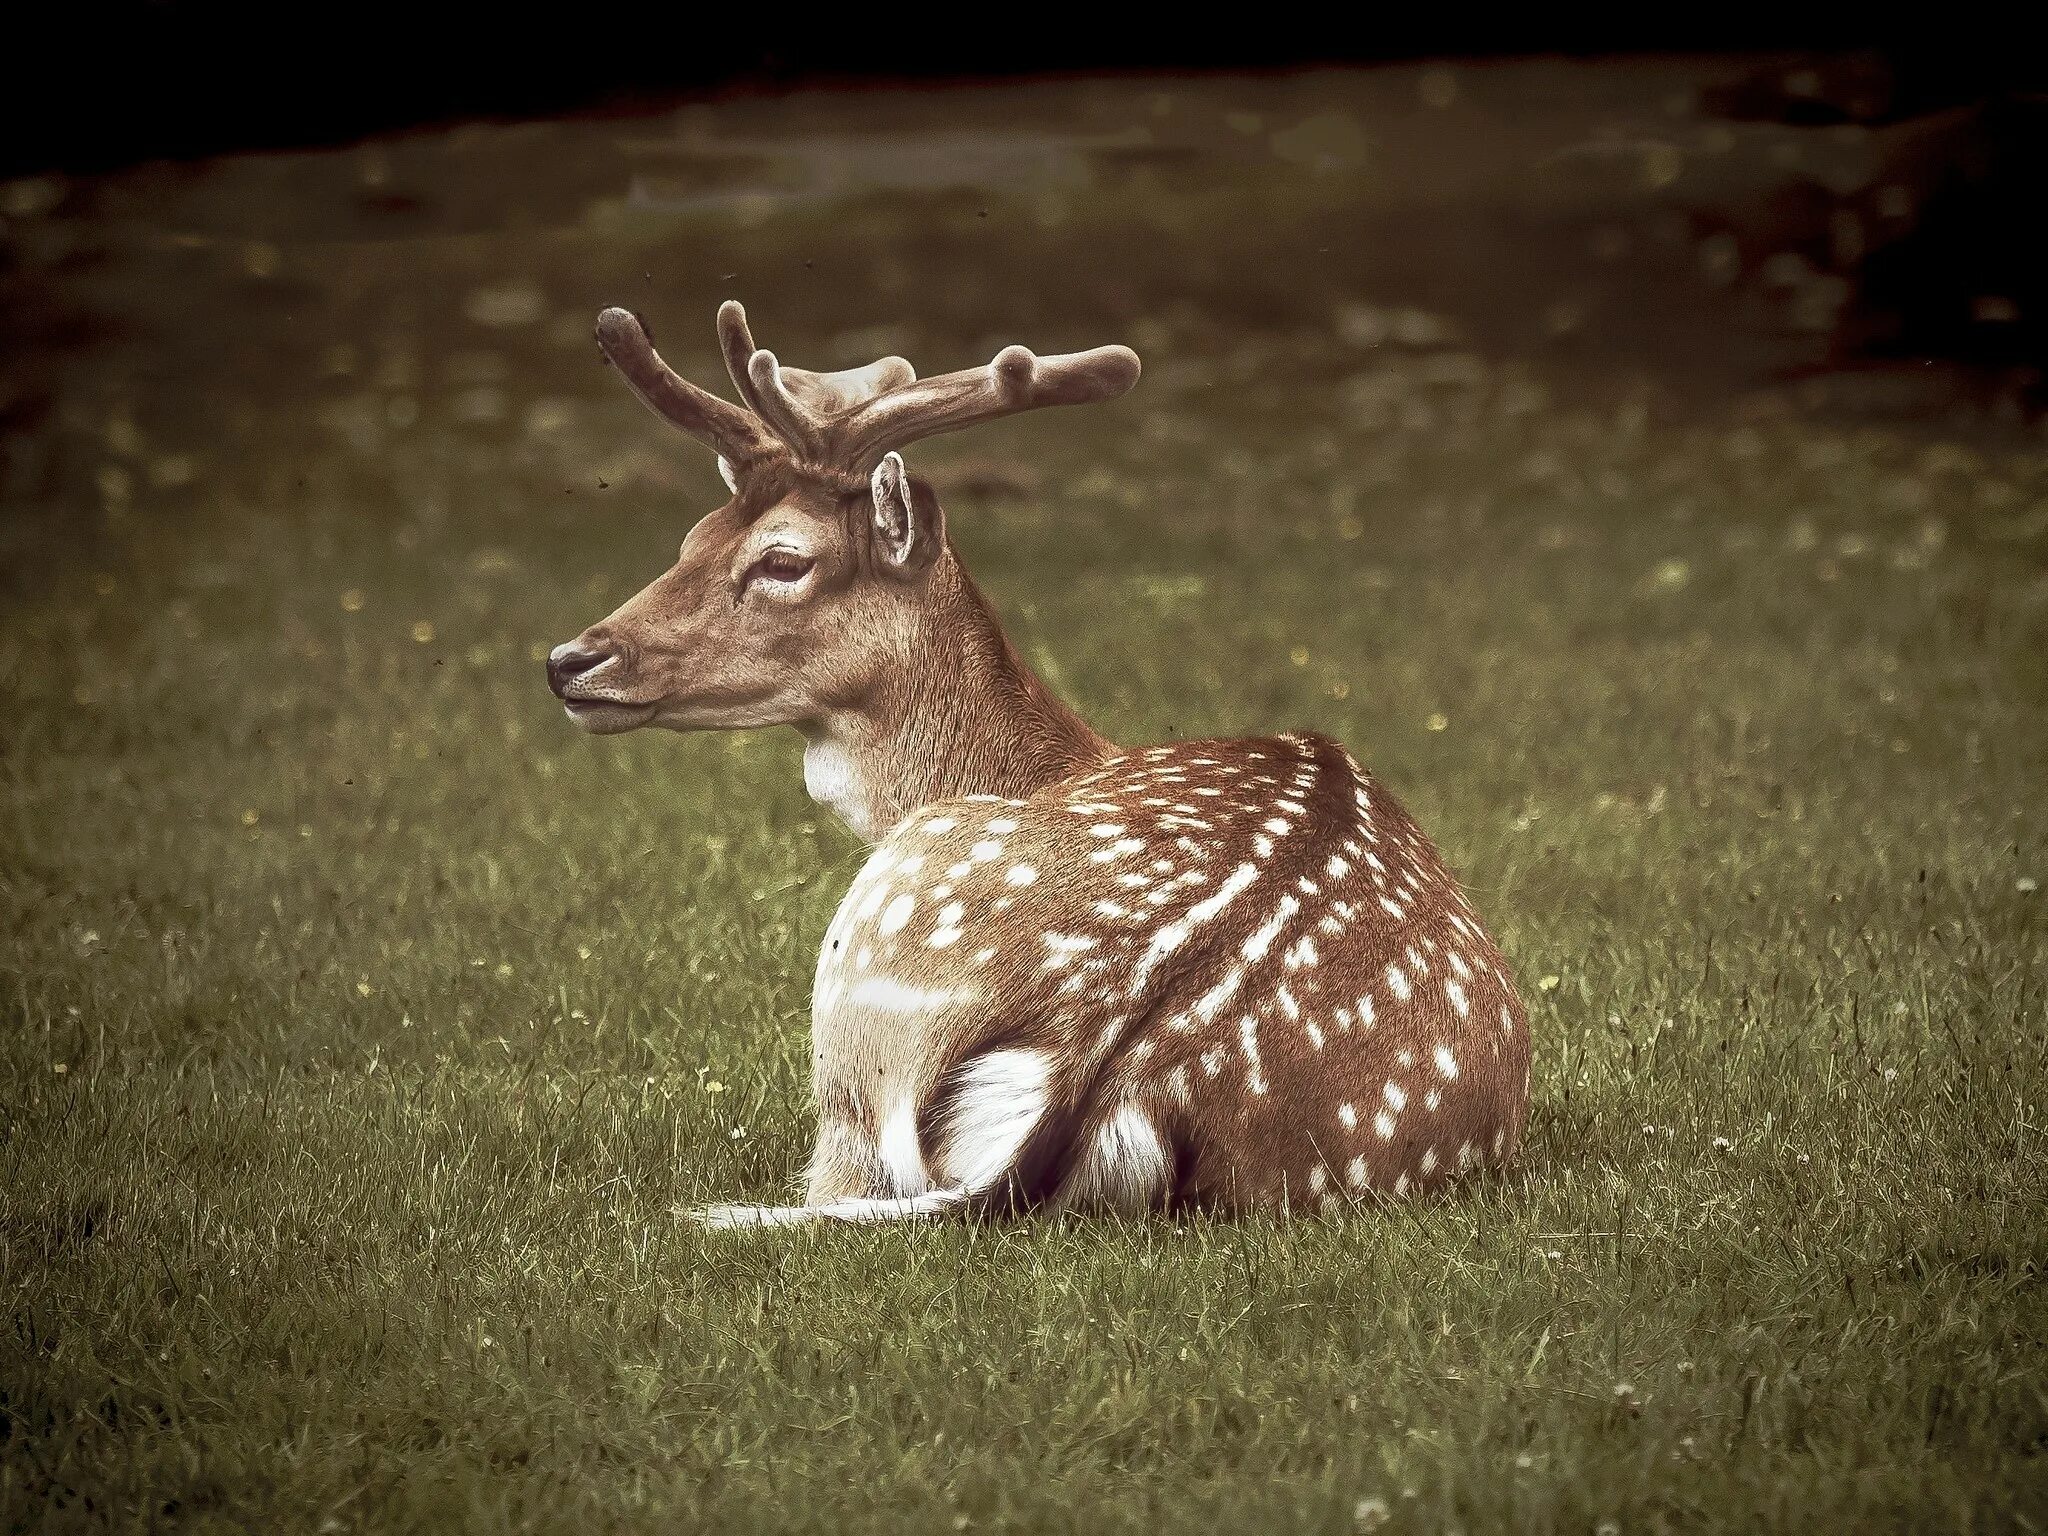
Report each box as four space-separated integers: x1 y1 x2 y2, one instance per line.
0 63 2048 1532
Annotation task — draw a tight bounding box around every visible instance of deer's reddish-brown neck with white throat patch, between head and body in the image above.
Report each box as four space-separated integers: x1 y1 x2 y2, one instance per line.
799 551 1116 842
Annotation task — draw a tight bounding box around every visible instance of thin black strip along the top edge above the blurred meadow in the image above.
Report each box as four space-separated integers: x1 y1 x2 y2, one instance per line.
0 0 2048 174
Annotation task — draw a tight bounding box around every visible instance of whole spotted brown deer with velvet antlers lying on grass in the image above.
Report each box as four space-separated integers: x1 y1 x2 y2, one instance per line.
547 301 1530 1229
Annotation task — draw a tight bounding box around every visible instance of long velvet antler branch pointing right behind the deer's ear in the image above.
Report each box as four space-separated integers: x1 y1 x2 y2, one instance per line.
836 346 1141 469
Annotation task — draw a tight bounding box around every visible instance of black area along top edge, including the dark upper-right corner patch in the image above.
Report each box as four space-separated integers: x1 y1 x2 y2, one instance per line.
12 12 2048 378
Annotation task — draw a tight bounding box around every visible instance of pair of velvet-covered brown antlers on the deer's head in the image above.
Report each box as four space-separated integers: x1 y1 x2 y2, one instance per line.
598 299 1139 475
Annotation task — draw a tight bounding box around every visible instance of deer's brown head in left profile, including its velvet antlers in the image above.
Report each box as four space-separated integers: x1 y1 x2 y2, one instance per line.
547 301 1139 733
